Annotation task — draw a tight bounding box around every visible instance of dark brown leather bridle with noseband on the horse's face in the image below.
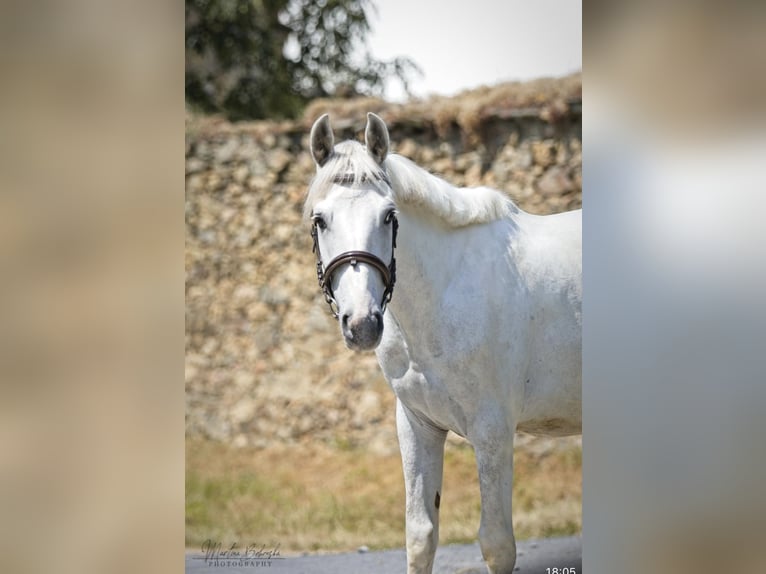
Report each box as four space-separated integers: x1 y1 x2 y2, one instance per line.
311 201 399 319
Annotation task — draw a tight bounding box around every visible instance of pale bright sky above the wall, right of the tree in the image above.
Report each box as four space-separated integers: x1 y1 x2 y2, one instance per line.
368 0 582 101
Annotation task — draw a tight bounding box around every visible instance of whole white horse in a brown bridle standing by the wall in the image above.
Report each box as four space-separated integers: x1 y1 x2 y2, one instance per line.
305 114 582 574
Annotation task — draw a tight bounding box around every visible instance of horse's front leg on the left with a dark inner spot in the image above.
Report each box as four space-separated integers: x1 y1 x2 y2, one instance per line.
396 399 447 574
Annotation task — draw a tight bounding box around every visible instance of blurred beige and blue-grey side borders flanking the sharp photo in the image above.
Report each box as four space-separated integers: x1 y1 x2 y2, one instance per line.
0 0 766 573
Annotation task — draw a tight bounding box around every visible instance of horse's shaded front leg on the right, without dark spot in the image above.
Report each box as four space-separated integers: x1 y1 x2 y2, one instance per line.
473 425 516 574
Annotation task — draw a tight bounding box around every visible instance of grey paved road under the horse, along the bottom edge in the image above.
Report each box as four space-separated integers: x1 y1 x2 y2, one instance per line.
186 536 582 574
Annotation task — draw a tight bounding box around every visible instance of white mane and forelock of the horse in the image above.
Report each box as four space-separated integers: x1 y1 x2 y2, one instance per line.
303 141 518 227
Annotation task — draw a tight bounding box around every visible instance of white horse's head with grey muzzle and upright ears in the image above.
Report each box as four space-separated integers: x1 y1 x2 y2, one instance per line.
310 114 398 351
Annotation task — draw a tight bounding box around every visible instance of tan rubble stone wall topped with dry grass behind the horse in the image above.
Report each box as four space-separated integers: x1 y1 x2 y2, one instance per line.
186 76 582 452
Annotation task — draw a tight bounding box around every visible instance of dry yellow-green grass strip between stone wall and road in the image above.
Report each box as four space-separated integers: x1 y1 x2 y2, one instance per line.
186 439 581 553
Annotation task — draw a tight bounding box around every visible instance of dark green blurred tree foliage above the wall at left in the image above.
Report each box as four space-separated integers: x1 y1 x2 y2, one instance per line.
186 0 419 120
